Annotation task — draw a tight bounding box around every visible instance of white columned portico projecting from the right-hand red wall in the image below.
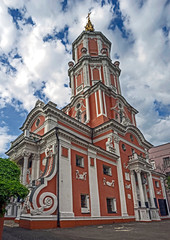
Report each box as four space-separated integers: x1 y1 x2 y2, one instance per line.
129 153 160 221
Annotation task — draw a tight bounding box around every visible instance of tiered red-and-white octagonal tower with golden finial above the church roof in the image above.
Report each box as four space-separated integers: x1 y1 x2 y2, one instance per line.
63 13 136 127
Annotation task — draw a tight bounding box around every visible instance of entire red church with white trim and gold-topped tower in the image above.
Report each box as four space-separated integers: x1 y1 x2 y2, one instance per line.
7 16 169 229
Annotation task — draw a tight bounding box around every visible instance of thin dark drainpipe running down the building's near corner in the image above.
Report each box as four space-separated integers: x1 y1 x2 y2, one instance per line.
56 127 60 227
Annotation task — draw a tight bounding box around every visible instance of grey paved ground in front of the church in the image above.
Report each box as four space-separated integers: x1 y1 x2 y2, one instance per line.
2 220 170 240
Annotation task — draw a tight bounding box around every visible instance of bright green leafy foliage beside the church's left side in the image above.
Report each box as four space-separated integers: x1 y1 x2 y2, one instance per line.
0 158 28 216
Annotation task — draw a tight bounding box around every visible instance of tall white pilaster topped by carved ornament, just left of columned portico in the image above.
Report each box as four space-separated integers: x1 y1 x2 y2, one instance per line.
114 133 128 216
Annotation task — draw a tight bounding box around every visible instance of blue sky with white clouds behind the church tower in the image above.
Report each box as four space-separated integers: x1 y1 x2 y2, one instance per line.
0 0 170 156
